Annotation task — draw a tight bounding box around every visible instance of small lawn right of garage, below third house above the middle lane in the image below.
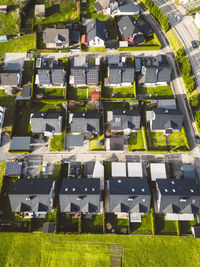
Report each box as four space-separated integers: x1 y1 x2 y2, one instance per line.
128 129 144 151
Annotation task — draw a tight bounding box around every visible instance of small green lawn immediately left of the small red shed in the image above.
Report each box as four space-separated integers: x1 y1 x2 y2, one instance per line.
68 87 94 100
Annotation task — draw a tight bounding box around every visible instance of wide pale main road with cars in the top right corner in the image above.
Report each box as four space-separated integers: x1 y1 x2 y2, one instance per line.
154 0 200 92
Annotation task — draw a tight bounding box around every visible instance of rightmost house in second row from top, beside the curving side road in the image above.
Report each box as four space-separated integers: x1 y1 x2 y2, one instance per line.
138 55 171 87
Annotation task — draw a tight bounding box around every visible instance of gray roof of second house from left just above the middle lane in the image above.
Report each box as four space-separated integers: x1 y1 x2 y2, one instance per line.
71 112 99 133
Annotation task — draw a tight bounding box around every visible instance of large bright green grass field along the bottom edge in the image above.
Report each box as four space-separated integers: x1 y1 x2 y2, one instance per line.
0 233 200 267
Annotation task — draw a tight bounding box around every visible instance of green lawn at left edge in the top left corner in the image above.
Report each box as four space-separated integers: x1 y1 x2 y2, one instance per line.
0 8 20 35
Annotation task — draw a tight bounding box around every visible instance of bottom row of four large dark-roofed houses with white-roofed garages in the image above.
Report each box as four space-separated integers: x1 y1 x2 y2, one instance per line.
9 162 200 222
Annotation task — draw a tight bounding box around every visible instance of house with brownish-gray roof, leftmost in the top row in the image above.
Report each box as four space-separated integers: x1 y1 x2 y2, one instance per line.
43 28 69 49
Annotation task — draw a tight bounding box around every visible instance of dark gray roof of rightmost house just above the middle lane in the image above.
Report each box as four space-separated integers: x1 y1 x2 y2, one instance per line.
152 109 184 130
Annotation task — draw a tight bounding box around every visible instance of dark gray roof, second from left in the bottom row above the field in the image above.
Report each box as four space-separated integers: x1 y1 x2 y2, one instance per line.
59 178 100 213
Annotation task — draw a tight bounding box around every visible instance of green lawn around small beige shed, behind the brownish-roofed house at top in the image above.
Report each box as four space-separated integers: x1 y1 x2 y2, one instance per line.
35 0 78 24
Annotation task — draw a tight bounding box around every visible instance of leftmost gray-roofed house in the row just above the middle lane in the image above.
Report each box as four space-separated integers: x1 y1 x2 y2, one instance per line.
30 111 63 137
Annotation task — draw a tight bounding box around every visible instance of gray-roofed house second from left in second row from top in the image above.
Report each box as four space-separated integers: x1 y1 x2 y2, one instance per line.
35 68 67 88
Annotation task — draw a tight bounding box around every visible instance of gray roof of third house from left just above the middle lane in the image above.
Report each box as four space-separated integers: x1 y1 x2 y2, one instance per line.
111 110 140 130
